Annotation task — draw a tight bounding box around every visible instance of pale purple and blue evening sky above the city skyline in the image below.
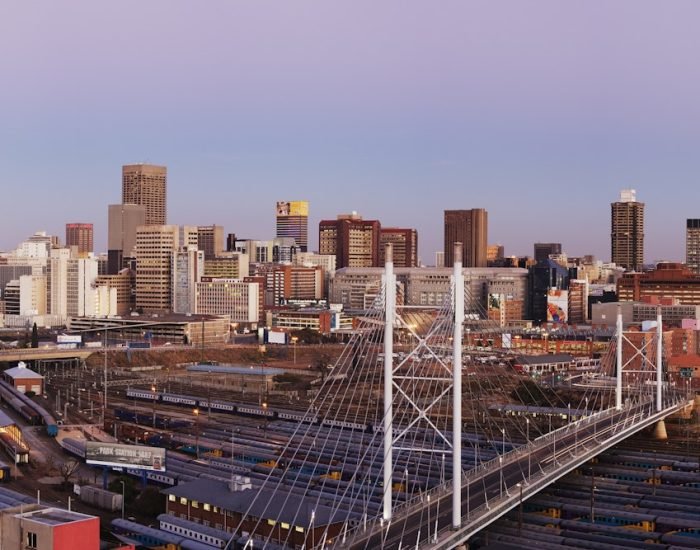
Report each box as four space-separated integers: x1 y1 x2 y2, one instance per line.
0 0 700 264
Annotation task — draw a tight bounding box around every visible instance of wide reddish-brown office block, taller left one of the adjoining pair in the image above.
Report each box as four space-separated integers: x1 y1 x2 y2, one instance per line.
318 212 381 269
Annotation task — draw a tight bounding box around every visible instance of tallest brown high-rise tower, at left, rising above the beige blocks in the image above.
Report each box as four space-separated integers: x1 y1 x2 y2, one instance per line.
122 164 167 225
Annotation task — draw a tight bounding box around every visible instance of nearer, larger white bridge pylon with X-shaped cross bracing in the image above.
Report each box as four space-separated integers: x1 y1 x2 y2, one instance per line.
382 243 464 528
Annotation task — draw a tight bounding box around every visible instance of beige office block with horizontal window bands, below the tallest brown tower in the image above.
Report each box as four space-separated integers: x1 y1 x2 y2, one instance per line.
136 225 197 312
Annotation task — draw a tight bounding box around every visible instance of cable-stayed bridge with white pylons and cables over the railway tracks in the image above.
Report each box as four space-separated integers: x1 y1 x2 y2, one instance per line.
232 246 688 549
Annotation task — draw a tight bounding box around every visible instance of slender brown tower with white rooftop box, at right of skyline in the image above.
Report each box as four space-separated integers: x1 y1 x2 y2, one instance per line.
610 189 644 271
